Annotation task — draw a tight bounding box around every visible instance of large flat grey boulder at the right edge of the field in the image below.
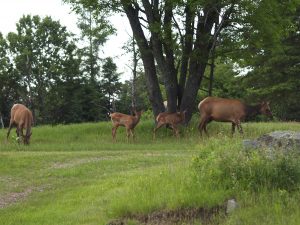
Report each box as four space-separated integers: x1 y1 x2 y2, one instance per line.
243 131 300 152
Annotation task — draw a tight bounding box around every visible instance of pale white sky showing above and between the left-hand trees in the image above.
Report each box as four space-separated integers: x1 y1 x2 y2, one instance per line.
0 0 131 81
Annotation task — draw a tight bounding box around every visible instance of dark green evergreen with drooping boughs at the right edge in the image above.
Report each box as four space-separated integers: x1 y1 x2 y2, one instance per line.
243 7 300 120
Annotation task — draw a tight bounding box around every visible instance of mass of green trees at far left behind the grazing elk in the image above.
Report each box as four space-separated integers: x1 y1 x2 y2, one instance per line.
0 16 116 126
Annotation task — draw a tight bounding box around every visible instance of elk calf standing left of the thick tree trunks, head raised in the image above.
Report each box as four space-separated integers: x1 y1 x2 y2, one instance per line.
110 111 143 141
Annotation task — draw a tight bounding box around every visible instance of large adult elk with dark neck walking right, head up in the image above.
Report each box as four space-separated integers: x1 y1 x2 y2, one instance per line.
198 97 272 136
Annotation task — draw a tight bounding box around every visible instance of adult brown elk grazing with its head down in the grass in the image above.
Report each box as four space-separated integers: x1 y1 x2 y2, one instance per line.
6 104 33 145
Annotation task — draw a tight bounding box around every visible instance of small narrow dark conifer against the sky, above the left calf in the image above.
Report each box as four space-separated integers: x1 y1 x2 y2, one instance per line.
101 57 121 111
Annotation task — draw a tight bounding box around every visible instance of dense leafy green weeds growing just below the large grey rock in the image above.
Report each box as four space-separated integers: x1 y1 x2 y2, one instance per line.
194 147 300 192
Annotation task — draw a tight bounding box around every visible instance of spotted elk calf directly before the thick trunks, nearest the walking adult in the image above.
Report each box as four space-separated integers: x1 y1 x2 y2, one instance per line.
153 110 186 139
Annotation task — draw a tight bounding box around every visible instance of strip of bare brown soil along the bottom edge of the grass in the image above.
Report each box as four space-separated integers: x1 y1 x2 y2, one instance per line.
107 206 225 225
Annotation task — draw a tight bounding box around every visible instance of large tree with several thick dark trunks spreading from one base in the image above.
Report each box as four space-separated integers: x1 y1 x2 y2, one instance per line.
64 0 297 122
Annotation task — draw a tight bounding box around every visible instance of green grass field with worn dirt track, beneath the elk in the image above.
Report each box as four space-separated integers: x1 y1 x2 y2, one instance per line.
0 120 300 225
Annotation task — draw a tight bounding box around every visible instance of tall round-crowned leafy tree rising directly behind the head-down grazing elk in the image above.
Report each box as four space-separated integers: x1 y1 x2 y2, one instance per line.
7 16 81 122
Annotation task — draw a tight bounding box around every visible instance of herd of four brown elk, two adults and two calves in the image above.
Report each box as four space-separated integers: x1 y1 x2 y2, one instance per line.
2 97 272 144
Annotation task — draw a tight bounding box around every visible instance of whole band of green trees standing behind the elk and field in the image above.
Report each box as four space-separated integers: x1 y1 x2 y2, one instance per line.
0 0 300 126
